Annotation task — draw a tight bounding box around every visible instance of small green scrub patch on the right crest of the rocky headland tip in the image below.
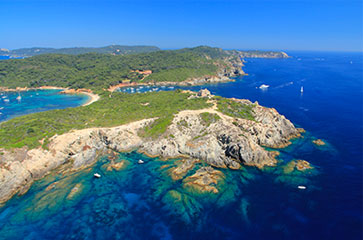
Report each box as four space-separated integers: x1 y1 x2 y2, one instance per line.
215 97 255 121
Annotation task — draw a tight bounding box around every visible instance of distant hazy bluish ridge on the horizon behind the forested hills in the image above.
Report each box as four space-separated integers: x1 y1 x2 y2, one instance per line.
0 45 160 57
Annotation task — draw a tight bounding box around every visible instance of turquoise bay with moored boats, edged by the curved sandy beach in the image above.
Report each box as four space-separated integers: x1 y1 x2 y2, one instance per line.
0 90 89 122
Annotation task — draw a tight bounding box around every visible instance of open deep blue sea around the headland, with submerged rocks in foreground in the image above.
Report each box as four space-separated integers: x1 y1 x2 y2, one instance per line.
0 52 363 239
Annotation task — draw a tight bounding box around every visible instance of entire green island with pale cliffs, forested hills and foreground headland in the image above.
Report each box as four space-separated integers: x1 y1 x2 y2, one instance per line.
0 46 302 203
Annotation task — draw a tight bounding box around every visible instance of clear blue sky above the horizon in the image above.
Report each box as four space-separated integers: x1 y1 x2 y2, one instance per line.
0 0 363 51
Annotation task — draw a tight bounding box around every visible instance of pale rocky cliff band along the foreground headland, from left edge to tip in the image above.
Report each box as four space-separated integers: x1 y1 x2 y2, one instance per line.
0 91 300 202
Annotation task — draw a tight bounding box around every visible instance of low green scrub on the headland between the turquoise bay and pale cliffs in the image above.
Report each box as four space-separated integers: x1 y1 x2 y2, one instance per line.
0 92 210 148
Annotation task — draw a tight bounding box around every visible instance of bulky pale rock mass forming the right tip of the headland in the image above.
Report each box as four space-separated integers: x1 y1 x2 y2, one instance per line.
140 97 300 169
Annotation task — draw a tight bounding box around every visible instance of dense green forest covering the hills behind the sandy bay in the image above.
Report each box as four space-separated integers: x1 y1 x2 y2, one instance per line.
0 47 228 91
